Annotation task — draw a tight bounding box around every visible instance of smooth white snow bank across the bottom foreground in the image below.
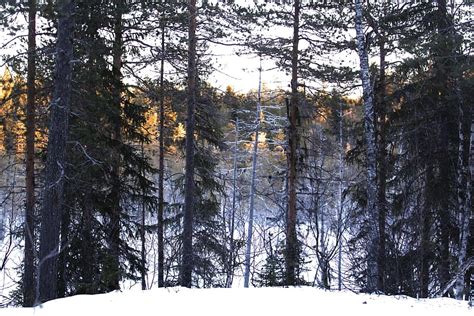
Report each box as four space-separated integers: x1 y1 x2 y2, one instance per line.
0 287 474 316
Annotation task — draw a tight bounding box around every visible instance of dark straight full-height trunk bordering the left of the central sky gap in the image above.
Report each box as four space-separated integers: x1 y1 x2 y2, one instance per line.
180 0 197 287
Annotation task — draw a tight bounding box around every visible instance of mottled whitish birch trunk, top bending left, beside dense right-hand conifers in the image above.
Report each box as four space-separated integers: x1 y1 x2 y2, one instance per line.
355 0 379 292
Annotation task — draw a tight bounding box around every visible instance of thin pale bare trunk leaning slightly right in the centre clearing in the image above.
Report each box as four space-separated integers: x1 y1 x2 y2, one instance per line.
244 57 262 287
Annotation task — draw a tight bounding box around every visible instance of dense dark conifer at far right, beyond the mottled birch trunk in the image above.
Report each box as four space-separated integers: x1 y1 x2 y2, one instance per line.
389 3 469 297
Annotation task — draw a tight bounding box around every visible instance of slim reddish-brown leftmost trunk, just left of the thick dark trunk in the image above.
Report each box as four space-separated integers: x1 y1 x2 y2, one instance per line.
23 0 36 307
